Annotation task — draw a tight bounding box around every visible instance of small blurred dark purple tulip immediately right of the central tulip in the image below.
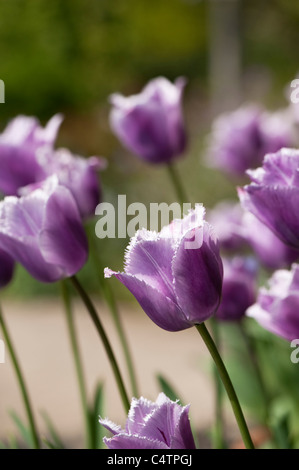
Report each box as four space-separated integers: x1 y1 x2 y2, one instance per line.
215 256 258 321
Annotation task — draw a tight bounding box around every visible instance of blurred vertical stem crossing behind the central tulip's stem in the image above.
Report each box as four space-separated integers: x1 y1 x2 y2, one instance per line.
211 318 226 449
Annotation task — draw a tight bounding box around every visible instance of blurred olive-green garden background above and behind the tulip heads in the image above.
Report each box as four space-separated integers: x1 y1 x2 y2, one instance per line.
0 0 299 296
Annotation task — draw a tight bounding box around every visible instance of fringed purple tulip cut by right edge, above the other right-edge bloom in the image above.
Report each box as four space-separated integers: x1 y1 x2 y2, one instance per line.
238 149 299 250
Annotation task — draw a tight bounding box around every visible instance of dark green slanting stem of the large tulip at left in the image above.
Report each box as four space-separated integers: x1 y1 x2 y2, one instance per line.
70 276 130 414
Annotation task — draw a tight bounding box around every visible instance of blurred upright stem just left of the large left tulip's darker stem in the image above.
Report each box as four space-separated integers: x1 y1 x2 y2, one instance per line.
61 281 92 449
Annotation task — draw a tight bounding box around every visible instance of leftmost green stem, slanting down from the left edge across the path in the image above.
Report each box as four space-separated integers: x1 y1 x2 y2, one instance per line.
0 307 41 449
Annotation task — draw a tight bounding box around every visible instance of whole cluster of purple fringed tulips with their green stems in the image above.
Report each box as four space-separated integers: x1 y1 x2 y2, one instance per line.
0 77 299 449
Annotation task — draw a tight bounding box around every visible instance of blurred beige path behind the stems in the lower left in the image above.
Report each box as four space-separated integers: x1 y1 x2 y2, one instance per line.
0 299 213 448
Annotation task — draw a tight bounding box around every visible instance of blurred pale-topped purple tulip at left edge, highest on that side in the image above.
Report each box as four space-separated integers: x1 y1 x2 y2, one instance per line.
0 114 62 195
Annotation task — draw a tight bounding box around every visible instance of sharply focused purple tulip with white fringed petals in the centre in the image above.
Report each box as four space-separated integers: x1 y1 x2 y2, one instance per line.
105 206 223 331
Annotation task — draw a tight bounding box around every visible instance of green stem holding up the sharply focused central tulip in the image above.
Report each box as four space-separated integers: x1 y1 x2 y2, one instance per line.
195 323 254 449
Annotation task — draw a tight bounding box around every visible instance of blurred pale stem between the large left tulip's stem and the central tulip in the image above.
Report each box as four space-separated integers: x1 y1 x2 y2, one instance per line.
88 222 139 397
